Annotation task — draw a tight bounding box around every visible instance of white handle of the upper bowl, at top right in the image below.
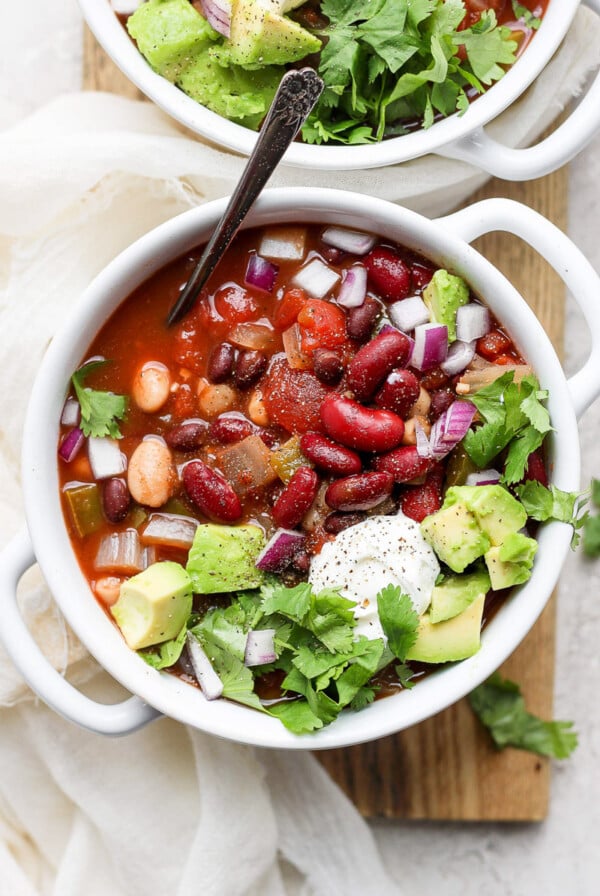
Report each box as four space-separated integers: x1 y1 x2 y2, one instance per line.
438 0 600 180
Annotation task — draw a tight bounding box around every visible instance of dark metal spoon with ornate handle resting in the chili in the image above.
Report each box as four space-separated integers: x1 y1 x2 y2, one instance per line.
167 68 323 326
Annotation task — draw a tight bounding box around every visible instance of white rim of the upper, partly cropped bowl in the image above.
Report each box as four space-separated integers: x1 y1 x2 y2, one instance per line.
78 0 581 171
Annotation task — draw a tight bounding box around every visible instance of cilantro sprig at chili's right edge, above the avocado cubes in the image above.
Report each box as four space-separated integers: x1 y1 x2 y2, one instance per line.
463 370 552 485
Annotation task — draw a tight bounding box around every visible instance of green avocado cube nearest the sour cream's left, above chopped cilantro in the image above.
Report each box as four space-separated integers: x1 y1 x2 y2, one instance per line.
186 523 265 594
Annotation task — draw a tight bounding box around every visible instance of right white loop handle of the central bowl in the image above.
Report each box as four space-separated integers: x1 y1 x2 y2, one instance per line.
437 199 600 417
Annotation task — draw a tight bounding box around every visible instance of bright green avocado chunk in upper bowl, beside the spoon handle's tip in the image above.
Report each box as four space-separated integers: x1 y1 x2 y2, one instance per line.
177 49 283 129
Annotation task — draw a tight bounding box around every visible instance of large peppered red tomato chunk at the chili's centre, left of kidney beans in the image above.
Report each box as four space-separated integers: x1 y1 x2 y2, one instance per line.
261 359 330 433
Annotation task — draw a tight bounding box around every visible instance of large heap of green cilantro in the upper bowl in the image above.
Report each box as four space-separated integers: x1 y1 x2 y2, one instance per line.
302 0 518 144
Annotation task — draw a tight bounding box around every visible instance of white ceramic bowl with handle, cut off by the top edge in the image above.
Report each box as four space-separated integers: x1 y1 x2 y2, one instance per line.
79 0 600 180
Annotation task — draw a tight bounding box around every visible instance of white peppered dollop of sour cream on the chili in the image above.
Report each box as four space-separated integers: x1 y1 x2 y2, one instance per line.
309 513 440 640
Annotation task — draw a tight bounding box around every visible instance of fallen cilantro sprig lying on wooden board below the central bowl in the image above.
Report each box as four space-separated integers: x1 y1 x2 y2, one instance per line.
469 672 577 759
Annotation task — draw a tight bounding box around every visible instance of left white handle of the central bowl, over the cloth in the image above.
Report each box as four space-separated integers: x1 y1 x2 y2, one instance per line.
0 528 160 735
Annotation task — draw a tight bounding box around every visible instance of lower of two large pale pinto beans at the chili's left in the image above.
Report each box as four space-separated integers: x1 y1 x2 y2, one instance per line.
127 436 177 507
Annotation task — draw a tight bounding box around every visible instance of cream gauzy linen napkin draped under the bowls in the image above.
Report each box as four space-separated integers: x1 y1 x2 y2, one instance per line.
0 0 600 896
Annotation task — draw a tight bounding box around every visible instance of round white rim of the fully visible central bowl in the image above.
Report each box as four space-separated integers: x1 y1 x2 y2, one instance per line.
22 188 579 750
